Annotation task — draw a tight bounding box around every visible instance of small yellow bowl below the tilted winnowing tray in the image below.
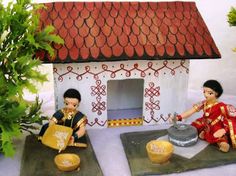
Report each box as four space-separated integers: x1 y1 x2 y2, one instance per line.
54 153 80 171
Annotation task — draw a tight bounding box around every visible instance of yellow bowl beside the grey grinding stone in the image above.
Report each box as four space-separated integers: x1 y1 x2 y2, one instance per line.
146 140 174 164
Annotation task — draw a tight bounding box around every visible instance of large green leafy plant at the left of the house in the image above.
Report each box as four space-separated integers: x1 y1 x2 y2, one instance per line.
0 0 63 156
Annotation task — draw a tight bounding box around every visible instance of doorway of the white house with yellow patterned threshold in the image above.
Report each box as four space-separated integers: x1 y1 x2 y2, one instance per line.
107 79 144 127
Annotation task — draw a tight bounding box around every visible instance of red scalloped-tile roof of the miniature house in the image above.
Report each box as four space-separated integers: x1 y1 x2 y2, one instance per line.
38 2 221 63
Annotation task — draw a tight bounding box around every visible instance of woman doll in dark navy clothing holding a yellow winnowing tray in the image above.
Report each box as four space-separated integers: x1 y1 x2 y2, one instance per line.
39 89 87 147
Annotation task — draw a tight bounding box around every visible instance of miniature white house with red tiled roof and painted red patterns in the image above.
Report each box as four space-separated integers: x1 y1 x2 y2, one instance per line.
39 2 220 128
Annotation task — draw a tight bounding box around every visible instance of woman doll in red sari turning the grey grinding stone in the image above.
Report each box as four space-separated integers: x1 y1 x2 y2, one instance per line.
176 80 236 152
